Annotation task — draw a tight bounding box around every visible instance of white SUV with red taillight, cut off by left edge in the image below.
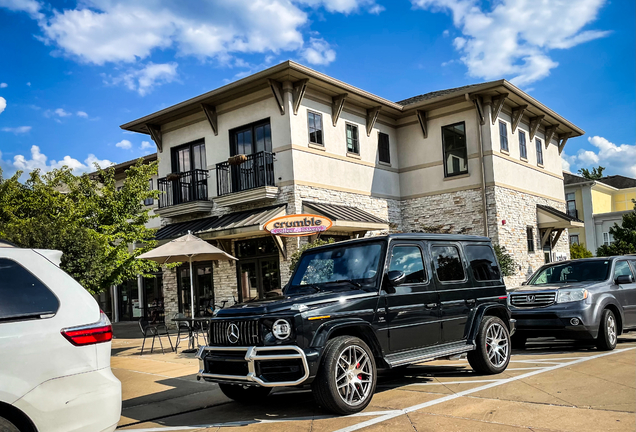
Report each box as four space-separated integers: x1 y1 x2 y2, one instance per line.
0 245 121 432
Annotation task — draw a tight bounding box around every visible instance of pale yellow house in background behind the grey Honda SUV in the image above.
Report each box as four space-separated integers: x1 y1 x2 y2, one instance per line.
563 172 636 255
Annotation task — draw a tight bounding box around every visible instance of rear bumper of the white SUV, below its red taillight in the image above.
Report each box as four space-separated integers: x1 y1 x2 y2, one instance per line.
13 367 121 432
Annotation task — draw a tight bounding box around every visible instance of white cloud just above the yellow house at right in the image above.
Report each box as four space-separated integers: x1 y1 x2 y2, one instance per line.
561 136 636 177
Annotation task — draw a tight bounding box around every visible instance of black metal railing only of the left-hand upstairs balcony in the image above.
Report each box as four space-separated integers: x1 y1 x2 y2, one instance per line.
157 170 208 208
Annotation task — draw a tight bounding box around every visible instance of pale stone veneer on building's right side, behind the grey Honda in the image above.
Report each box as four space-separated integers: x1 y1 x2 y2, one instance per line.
487 186 570 288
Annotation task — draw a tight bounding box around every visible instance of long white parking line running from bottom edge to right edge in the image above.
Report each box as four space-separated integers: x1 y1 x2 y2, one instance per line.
335 347 636 432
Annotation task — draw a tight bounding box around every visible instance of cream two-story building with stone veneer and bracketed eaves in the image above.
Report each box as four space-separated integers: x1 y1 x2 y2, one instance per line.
122 61 583 316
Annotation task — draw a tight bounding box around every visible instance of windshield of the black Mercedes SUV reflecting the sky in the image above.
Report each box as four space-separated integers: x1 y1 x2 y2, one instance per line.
287 243 383 294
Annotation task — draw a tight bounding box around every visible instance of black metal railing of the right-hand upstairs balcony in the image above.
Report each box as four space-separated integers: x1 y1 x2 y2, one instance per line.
216 151 274 196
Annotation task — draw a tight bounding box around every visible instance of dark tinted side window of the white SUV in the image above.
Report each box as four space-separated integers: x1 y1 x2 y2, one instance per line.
0 258 60 320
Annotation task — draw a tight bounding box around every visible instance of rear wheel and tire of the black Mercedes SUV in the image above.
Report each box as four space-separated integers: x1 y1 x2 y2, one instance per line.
467 316 510 375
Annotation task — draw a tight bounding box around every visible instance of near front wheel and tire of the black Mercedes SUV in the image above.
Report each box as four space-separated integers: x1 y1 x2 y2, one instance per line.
312 336 377 415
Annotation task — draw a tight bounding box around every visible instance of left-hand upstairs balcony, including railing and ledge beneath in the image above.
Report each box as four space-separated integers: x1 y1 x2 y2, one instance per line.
155 169 212 217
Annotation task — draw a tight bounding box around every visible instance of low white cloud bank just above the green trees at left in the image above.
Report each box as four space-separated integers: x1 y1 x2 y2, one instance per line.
0 145 113 175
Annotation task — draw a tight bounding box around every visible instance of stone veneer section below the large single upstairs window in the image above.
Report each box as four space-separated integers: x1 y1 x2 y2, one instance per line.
401 188 484 235
